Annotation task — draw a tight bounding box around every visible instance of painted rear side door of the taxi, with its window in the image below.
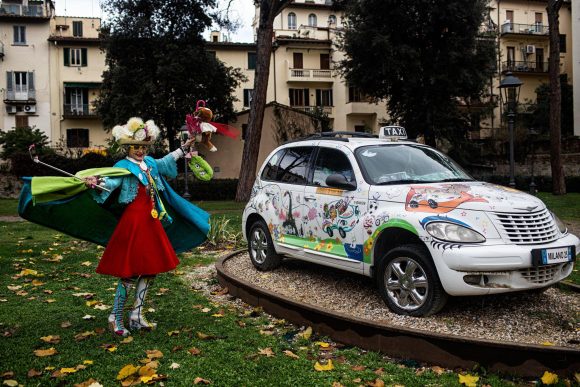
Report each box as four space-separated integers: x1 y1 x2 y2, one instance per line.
264 146 314 257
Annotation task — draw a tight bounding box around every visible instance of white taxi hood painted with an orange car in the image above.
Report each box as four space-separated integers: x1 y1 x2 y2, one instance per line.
369 182 546 213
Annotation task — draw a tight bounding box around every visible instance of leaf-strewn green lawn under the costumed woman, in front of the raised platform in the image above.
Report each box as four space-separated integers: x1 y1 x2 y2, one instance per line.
0 222 524 386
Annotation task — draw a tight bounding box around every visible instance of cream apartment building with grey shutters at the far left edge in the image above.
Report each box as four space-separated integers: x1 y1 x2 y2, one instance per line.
0 0 54 136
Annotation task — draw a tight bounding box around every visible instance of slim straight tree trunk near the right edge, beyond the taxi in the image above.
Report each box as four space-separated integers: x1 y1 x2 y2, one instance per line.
546 0 566 195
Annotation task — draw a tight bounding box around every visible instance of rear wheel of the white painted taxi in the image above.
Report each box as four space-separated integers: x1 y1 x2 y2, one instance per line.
248 221 282 271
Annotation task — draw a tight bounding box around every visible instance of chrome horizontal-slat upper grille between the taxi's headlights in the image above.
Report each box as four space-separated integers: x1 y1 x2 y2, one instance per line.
494 210 558 245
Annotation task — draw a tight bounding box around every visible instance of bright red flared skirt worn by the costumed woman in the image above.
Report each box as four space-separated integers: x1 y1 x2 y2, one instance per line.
97 184 179 278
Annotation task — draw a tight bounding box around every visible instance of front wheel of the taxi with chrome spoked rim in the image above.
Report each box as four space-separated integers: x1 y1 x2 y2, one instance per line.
377 245 447 317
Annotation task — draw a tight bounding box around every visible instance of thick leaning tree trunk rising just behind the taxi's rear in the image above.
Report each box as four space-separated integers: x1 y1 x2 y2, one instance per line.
236 0 290 202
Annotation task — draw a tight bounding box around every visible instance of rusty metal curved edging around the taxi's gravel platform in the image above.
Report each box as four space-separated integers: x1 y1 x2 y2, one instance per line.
215 249 580 377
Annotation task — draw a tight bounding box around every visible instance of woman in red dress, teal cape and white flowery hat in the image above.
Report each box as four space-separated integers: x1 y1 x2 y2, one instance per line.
19 118 209 336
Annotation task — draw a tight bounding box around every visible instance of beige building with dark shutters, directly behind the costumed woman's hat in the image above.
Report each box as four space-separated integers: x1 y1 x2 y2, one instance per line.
47 16 110 148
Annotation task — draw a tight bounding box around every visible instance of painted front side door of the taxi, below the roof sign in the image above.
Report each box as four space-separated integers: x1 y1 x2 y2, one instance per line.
302 144 368 272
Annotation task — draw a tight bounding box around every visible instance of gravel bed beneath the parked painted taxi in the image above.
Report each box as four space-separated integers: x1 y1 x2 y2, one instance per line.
220 253 580 349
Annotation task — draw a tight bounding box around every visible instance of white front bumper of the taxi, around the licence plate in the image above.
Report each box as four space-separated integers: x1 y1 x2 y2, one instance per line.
431 234 580 296
